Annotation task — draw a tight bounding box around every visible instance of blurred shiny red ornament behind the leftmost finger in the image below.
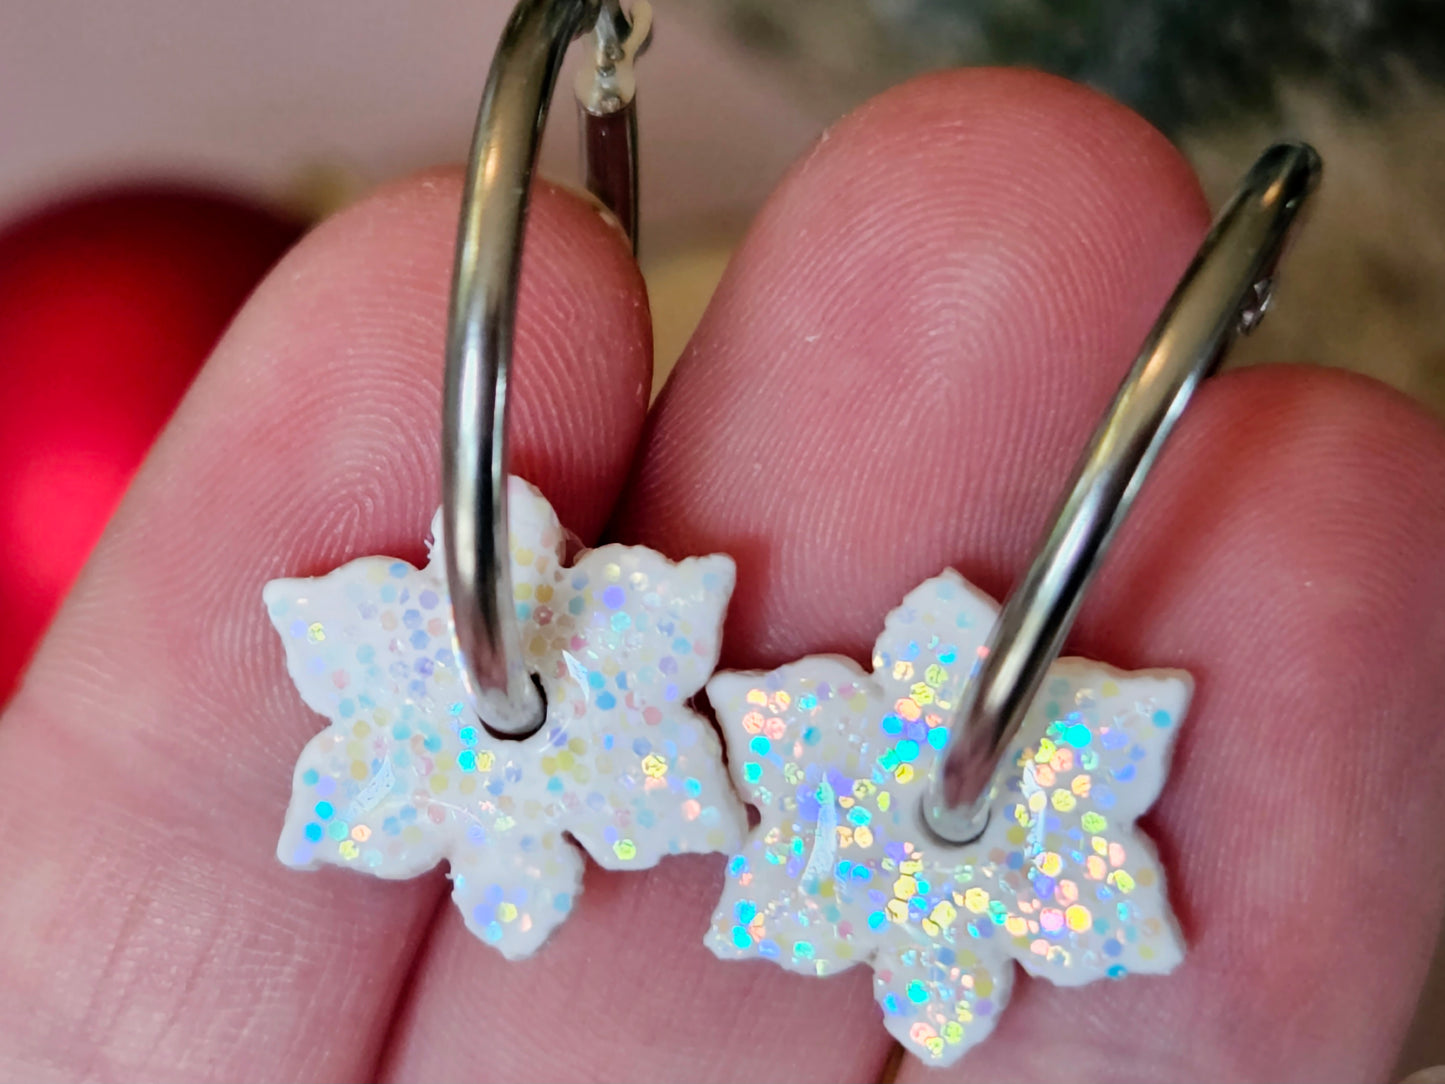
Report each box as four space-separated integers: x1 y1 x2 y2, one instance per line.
0 188 301 701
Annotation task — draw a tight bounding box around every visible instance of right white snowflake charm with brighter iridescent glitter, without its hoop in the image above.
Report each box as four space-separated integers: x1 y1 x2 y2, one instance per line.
708 571 1191 1064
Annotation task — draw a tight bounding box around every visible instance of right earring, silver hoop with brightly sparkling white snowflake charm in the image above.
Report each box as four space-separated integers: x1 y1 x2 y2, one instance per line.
708 146 1319 1064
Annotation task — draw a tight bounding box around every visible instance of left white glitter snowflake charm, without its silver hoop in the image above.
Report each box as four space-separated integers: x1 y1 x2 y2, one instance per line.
264 478 747 957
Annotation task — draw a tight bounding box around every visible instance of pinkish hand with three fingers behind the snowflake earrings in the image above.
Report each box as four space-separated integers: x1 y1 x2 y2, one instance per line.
0 71 1445 1081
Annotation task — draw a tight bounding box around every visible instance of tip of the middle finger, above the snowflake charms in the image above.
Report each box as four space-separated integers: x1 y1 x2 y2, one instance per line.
624 69 1207 665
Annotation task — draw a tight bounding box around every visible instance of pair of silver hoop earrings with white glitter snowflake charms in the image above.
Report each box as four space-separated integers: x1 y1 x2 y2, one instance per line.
264 0 1319 1064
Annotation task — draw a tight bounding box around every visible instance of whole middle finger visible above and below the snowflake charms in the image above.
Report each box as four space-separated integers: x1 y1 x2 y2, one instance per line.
389 71 1207 1081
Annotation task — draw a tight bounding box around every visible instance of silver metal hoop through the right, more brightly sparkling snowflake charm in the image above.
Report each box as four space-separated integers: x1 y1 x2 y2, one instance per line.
923 143 1321 844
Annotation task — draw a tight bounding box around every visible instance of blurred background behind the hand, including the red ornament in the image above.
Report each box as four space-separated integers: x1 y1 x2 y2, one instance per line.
0 0 1445 1070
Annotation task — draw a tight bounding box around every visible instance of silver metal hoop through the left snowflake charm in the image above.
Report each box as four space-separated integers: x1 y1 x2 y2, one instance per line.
442 0 637 734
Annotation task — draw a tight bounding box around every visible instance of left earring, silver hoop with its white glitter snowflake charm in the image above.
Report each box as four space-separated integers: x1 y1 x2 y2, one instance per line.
264 0 746 957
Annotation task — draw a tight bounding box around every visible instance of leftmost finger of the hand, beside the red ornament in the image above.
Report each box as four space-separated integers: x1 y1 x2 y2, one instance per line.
0 173 650 1080
